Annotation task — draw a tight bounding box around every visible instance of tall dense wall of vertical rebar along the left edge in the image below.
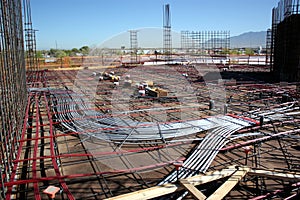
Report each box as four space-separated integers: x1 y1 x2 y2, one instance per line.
0 0 27 197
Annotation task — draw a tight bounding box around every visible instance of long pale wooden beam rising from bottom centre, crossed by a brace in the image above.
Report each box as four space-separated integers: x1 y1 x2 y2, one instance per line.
108 166 237 200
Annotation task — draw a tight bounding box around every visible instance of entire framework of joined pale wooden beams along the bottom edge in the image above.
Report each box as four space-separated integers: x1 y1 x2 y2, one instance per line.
109 166 300 200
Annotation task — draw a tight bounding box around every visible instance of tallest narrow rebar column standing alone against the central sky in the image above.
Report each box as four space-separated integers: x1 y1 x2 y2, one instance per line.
163 4 172 60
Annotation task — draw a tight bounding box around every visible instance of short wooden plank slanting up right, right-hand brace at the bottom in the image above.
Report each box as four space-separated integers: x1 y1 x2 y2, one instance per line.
207 167 250 200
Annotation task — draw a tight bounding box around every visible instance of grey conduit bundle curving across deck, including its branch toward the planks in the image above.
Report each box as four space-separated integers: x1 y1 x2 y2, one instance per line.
52 91 295 197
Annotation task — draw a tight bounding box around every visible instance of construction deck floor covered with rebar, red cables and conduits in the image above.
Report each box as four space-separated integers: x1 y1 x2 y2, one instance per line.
2 61 300 199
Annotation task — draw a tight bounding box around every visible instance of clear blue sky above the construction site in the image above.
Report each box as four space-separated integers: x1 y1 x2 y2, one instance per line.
31 0 278 49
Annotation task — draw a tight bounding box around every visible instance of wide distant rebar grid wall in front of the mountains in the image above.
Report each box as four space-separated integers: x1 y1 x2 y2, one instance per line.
181 31 230 55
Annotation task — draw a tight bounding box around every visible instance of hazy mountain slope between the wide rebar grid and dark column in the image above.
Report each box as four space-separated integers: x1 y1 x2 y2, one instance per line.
230 31 267 48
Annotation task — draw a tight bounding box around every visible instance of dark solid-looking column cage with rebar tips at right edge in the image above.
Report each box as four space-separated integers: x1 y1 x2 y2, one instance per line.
267 0 300 81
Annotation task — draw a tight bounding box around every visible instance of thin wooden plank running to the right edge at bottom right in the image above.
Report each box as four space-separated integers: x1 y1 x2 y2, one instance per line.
249 169 300 181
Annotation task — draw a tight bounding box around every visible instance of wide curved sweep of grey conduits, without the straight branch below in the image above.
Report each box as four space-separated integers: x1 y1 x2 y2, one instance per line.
52 92 251 144
